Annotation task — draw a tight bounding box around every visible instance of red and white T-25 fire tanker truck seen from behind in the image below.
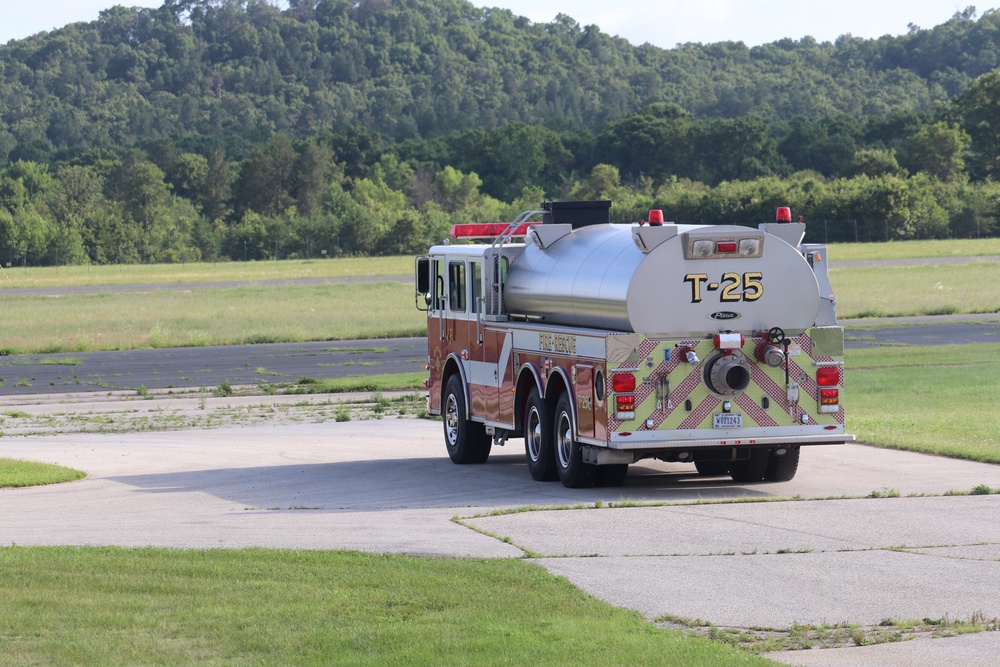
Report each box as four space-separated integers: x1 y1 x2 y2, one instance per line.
415 201 854 488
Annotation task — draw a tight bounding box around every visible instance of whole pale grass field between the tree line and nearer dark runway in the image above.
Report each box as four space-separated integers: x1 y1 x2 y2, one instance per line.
0 239 1000 354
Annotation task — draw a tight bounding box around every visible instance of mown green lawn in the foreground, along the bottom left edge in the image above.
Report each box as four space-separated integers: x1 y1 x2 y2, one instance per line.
0 547 774 665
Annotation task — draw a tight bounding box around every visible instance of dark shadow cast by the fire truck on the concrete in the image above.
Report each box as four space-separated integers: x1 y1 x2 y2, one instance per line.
105 453 780 512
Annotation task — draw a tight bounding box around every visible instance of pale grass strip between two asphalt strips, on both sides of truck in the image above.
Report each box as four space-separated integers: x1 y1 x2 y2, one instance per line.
0 262 1000 354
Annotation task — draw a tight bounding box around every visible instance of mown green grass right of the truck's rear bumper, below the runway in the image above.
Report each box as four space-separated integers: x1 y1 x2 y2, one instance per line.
844 343 1000 463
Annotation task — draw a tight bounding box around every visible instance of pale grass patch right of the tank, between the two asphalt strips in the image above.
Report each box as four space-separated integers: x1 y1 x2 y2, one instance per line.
830 261 1000 319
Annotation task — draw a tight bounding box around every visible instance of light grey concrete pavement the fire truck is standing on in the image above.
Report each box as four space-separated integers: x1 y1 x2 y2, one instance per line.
0 414 1000 665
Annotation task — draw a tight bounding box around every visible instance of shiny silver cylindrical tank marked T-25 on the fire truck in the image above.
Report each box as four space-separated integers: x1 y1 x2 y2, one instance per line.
504 224 832 336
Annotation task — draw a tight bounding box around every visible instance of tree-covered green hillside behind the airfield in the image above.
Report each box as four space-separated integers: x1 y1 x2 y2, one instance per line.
0 0 1000 264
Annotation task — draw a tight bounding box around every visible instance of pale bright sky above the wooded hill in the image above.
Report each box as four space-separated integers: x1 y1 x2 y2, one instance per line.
0 0 990 48
